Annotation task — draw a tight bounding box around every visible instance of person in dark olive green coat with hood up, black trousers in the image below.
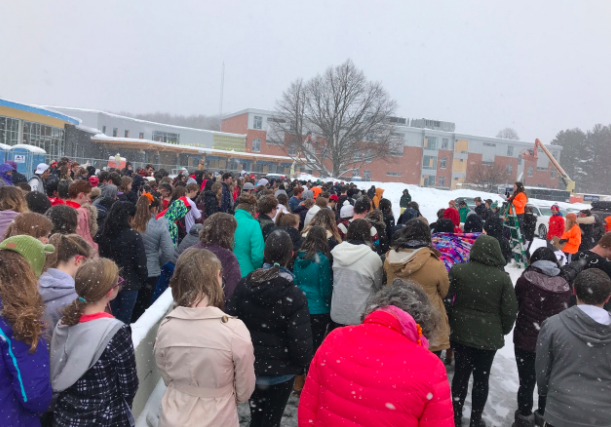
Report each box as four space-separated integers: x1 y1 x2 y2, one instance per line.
445 235 518 427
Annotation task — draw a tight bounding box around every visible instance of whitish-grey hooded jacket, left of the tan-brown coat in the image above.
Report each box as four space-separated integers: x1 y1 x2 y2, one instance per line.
331 242 383 325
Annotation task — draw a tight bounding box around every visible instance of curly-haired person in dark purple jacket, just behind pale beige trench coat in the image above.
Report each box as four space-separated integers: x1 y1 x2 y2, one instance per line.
193 212 242 301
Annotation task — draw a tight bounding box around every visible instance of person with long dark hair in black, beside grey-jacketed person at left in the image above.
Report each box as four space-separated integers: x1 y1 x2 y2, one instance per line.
96 202 148 325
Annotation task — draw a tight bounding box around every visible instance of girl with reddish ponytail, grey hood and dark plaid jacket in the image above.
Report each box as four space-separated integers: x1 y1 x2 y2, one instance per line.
51 258 138 427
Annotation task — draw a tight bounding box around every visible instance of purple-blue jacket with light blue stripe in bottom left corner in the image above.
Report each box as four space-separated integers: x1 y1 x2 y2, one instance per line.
0 302 53 427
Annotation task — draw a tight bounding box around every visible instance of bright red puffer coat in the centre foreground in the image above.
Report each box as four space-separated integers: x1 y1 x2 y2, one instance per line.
298 310 454 427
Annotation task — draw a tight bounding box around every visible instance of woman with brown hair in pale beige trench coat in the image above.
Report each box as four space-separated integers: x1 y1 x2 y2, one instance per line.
155 248 255 427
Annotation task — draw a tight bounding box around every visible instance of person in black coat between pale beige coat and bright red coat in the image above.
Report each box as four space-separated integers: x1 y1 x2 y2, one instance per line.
227 232 312 427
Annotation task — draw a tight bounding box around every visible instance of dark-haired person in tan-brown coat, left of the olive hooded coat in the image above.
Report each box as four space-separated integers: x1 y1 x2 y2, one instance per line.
384 219 450 355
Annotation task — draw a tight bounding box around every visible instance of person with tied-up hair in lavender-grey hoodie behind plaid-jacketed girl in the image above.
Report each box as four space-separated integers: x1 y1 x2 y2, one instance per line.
39 233 91 338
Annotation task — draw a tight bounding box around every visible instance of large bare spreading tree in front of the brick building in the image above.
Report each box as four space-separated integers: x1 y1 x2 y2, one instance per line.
268 60 396 177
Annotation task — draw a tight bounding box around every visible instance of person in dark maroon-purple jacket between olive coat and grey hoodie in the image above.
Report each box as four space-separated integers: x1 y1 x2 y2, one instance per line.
513 247 571 427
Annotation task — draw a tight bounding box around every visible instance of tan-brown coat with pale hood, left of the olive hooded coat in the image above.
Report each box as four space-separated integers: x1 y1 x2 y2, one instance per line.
384 247 450 351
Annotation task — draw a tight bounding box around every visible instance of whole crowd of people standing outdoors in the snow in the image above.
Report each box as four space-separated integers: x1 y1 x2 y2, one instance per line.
0 159 611 427
